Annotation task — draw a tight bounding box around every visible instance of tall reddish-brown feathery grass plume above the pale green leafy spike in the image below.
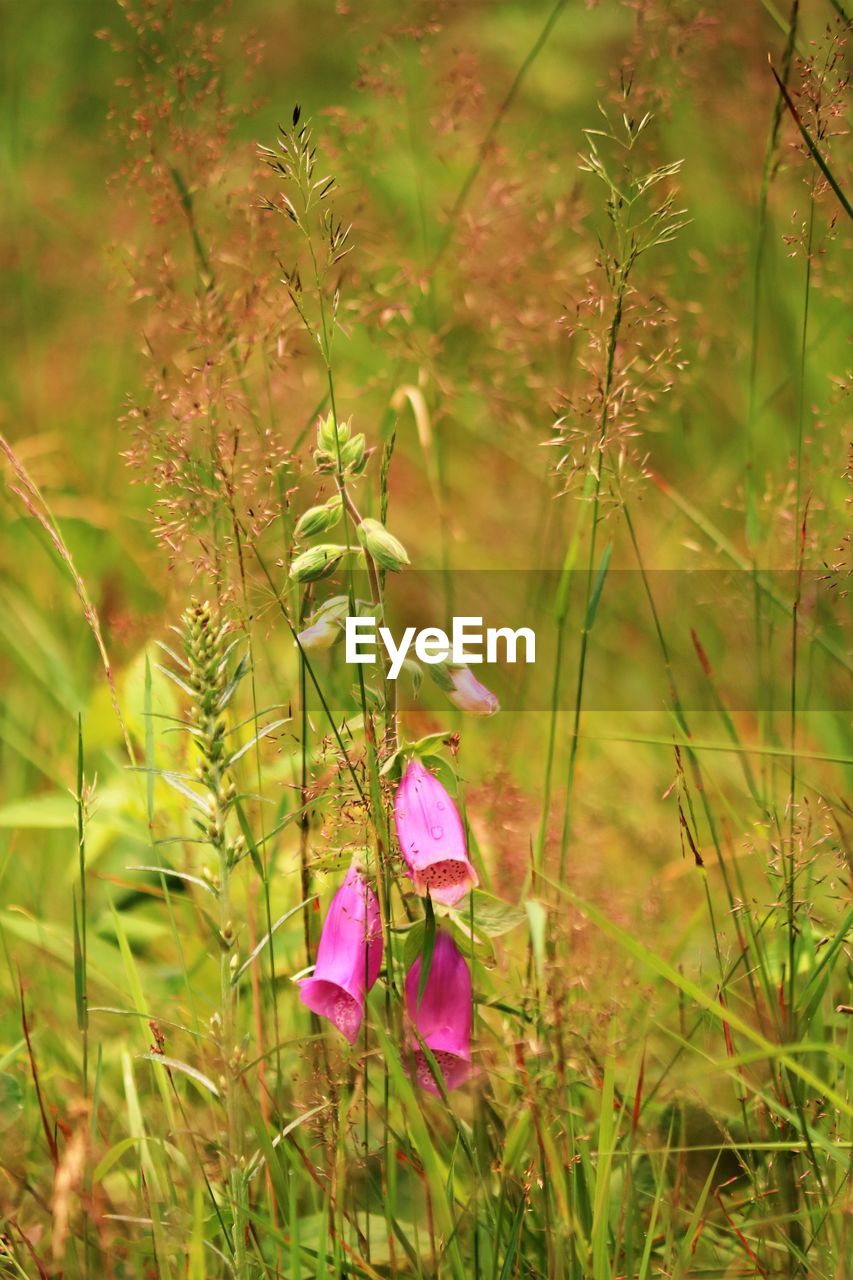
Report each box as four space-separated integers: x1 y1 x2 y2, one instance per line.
106 0 292 588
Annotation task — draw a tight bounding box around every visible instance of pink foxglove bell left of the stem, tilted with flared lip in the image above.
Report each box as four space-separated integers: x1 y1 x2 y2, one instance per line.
300 867 382 1044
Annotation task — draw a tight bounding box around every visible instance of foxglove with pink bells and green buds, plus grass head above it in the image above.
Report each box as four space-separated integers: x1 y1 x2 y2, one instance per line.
261 109 498 1111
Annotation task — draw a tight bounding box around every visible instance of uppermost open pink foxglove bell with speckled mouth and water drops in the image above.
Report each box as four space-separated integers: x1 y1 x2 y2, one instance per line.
394 760 479 906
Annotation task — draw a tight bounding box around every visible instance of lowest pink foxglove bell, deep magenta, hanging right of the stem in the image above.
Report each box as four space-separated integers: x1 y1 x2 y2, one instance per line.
406 932 471 1096
